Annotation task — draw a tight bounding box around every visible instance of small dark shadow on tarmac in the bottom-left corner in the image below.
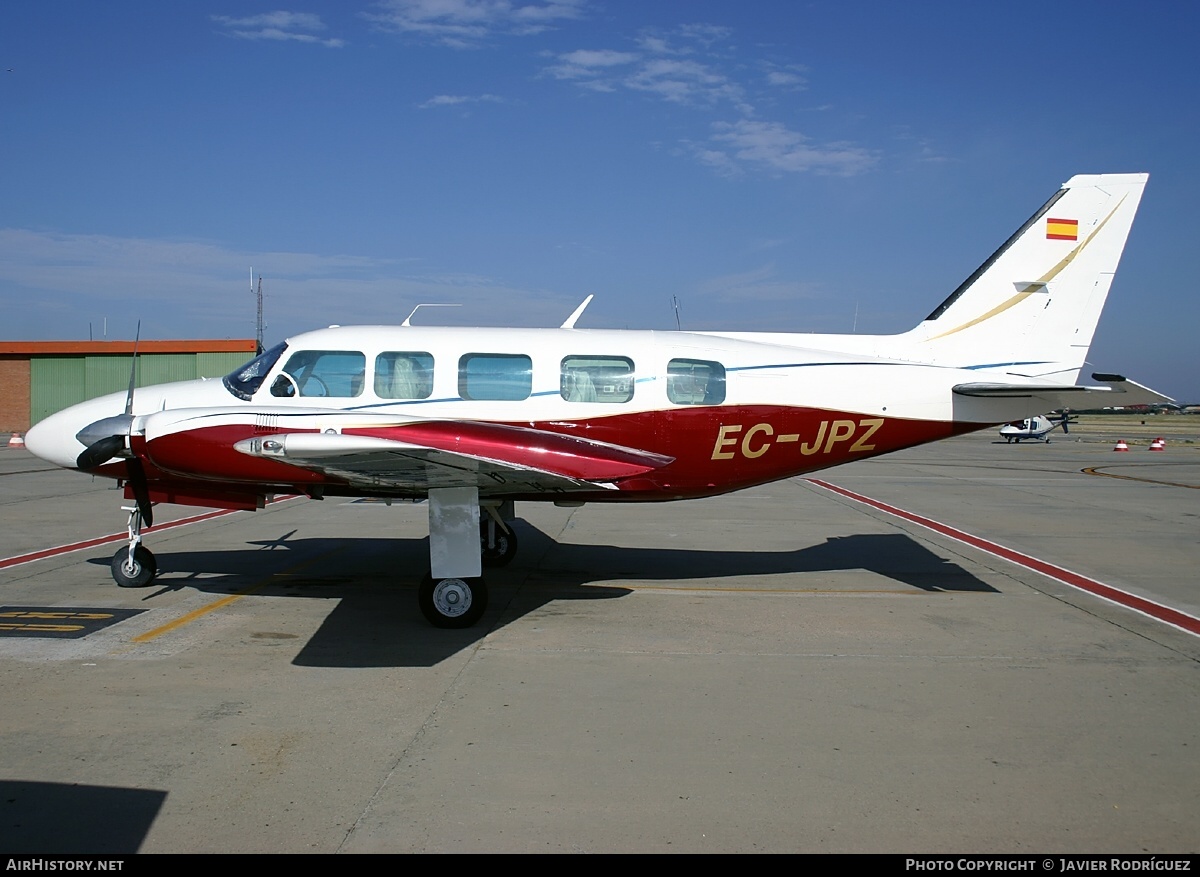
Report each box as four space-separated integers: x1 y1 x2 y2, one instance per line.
0 780 167 855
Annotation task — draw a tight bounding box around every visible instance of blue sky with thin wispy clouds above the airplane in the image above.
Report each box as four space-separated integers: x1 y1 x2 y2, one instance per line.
0 0 1200 401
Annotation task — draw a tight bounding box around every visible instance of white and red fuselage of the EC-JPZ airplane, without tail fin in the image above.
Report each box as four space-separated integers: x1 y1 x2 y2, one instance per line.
26 326 1014 507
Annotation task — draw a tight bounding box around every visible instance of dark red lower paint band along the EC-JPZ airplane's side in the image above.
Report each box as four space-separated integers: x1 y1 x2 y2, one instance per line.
140 406 985 501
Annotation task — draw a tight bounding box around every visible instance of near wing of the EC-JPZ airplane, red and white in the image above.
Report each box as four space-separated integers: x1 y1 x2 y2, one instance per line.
234 421 673 495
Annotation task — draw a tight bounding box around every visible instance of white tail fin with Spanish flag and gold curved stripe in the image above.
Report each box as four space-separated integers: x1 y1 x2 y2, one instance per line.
907 174 1148 384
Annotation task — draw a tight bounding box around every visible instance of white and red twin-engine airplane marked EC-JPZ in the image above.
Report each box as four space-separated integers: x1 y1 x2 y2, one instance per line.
25 174 1165 627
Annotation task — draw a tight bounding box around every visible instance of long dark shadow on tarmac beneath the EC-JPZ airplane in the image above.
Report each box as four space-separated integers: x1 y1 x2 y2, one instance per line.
91 522 996 667
